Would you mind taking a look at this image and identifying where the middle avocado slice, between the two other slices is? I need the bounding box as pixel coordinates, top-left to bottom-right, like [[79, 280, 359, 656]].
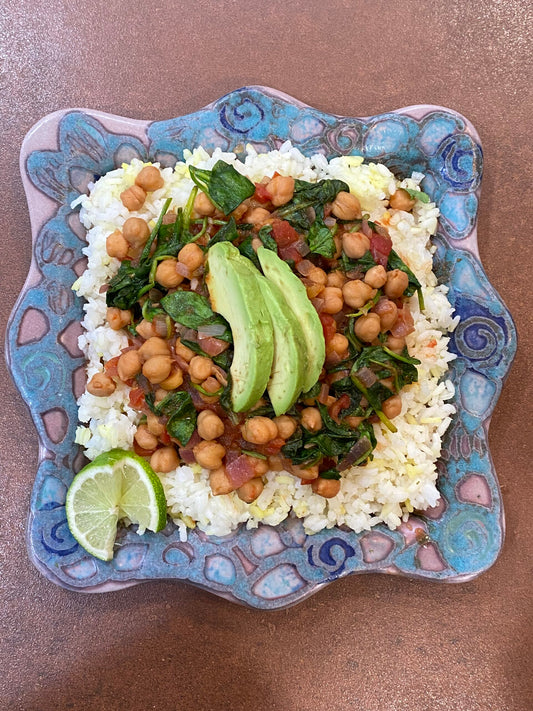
[[258, 275, 307, 415]]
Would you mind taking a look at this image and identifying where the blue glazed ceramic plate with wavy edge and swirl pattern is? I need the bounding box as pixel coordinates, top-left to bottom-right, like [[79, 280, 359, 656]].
[[7, 87, 516, 609]]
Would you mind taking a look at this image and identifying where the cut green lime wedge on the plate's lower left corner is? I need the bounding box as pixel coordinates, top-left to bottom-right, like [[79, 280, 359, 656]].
[[65, 449, 167, 560]]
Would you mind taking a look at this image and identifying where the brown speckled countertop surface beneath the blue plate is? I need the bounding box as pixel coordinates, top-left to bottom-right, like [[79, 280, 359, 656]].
[[0, 0, 533, 711]]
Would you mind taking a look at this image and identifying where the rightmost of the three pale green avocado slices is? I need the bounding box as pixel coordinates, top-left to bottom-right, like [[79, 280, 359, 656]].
[[257, 247, 326, 392]]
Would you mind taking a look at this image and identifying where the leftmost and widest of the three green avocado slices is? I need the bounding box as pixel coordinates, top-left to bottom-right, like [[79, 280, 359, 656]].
[[205, 242, 274, 412]]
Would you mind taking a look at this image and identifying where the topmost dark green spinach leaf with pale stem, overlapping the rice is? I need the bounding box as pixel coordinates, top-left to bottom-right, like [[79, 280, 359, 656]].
[[189, 160, 255, 215]]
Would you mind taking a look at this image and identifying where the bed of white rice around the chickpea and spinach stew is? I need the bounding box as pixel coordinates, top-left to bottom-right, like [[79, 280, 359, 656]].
[[73, 142, 458, 540]]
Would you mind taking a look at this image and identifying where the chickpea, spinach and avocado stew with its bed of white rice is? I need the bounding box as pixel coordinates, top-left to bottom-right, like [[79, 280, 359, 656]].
[[68, 142, 457, 552]]
